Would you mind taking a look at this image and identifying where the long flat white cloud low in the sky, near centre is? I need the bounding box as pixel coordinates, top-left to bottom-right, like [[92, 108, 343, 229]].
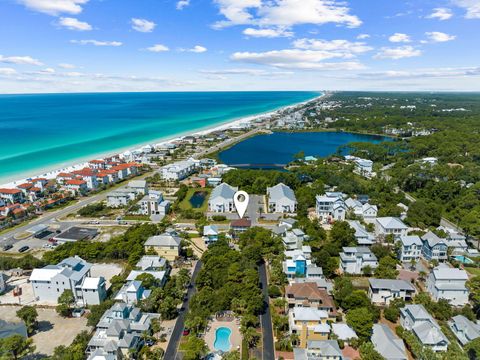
[[231, 49, 363, 70]]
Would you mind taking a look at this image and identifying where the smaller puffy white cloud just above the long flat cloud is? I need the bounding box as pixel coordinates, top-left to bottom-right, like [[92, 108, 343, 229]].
[[293, 39, 373, 58]]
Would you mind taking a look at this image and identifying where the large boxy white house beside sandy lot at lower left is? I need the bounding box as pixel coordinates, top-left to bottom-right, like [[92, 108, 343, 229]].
[[29, 256, 107, 306]]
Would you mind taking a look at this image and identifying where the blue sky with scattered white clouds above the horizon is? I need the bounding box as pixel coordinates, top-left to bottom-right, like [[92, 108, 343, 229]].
[[0, 0, 480, 93]]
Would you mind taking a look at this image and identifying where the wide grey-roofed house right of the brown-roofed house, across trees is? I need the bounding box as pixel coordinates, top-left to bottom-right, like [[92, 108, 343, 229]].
[[368, 279, 415, 305]]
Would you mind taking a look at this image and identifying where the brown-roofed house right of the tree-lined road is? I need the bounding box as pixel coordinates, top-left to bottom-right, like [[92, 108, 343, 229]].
[[285, 282, 337, 321]]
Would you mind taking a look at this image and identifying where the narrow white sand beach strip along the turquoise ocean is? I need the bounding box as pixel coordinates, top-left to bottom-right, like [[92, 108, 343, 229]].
[[0, 91, 328, 188]]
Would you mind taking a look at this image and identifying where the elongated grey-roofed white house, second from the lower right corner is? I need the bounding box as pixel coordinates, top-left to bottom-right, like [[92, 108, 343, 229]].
[[400, 304, 449, 351]]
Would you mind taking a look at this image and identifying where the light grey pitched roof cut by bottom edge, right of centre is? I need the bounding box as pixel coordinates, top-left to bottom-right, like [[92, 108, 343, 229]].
[[371, 324, 408, 360]]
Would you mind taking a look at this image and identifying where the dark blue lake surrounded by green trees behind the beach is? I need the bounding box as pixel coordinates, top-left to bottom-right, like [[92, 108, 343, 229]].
[[218, 132, 389, 169]]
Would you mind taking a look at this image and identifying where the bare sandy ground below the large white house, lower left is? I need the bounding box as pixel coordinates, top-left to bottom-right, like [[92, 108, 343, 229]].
[[0, 306, 90, 356]]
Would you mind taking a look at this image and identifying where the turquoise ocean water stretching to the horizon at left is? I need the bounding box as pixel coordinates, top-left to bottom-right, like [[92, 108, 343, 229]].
[[0, 92, 320, 184]]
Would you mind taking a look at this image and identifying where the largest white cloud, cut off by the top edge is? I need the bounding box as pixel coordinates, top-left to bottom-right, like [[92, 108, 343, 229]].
[[214, 0, 362, 28]]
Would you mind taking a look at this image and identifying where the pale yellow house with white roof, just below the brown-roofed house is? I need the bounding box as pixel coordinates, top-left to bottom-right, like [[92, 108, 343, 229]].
[[288, 307, 330, 348]]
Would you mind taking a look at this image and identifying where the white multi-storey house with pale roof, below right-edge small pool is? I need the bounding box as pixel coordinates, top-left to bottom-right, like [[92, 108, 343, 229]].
[[426, 266, 469, 306]]
